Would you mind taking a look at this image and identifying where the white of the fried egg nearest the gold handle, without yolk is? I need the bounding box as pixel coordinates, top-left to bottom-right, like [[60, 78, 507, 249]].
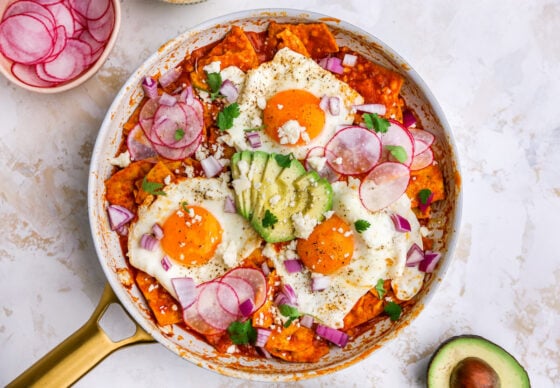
[[128, 178, 261, 296]]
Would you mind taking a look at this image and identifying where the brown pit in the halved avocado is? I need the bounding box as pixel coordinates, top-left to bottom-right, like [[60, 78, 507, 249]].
[[449, 357, 501, 388]]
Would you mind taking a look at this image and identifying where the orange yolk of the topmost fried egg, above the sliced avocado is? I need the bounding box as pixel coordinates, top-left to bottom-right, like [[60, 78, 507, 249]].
[[263, 89, 325, 146]]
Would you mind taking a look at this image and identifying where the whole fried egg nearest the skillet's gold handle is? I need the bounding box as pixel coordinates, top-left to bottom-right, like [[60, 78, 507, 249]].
[[128, 178, 261, 297]]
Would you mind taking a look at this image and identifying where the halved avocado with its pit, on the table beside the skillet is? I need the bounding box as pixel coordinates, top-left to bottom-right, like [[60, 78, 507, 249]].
[[427, 335, 531, 388]]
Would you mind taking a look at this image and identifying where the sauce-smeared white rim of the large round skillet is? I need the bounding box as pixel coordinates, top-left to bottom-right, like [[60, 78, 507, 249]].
[[88, 8, 462, 382]]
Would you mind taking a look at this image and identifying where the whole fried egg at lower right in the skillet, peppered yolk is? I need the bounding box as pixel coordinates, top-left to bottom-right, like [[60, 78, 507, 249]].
[[263, 179, 423, 328]]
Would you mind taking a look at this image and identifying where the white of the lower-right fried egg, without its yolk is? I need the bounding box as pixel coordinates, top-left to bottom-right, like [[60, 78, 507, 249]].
[[263, 179, 424, 328]]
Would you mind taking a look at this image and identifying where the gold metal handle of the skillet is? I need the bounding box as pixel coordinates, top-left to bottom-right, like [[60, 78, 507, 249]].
[[7, 284, 154, 388]]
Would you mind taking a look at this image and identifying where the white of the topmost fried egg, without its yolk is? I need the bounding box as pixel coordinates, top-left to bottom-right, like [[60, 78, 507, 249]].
[[223, 48, 364, 159]]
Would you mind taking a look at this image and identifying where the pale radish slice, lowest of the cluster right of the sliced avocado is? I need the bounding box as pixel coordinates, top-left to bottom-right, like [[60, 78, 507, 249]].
[[360, 162, 410, 212]]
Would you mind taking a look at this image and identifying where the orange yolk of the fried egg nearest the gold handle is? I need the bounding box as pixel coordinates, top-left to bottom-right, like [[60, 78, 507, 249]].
[[161, 206, 223, 266]]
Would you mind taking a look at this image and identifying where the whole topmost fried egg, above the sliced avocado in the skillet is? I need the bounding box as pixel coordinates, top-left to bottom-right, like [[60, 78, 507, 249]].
[[224, 48, 363, 159]]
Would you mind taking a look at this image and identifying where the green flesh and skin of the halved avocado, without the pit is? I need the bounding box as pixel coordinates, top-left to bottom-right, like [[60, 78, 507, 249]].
[[426, 334, 531, 388]]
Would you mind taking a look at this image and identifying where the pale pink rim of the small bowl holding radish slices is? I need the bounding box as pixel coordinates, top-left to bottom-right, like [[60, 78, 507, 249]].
[[0, 0, 122, 94]]
